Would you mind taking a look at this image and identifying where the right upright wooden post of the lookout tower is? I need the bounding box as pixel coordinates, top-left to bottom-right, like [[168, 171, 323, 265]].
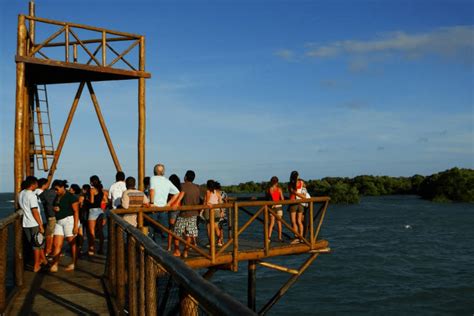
[[138, 36, 146, 191]]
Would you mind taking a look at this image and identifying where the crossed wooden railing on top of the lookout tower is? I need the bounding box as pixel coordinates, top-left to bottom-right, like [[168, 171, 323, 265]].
[[19, 15, 145, 71]]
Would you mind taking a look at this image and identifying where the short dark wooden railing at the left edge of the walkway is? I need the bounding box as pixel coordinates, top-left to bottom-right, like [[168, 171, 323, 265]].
[[0, 212, 24, 315]]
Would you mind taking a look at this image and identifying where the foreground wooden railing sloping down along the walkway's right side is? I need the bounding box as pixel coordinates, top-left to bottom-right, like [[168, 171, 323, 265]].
[[106, 213, 255, 316]]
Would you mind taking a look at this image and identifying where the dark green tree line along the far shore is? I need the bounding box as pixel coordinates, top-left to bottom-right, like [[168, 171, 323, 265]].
[[223, 168, 474, 204]]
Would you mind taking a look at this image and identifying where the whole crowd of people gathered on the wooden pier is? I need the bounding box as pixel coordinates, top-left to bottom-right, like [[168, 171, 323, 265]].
[[18, 164, 308, 272]]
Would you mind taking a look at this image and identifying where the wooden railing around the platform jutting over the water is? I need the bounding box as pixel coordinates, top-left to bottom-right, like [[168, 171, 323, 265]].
[[114, 197, 330, 271]]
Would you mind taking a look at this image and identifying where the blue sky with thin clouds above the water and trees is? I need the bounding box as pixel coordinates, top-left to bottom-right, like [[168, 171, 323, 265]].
[[0, 0, 474, 191]]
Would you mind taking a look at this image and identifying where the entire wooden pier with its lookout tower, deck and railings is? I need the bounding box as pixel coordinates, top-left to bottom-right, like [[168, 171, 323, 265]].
[[0, 2, 330, 316]]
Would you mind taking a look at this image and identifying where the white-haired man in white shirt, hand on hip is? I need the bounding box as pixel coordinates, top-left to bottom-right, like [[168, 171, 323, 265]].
[[150, 164, 179, 237]]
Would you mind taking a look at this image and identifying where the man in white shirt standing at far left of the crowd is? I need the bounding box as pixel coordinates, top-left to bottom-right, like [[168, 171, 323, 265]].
[[19, 176, 48, 272]]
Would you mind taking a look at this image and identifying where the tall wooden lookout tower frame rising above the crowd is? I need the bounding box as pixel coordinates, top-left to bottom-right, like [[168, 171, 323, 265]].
[[14, 1, 151, 200]]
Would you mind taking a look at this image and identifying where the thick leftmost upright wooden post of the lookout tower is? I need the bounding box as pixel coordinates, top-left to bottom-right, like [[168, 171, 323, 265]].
[[14, 15, 27, 198]]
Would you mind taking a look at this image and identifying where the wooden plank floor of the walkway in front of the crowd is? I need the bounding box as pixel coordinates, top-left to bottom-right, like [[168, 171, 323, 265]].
[[9, 255, 110, 315]]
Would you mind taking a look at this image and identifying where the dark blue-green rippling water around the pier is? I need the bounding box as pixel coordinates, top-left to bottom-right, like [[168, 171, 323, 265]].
[[0, 193, 474, 315]]
